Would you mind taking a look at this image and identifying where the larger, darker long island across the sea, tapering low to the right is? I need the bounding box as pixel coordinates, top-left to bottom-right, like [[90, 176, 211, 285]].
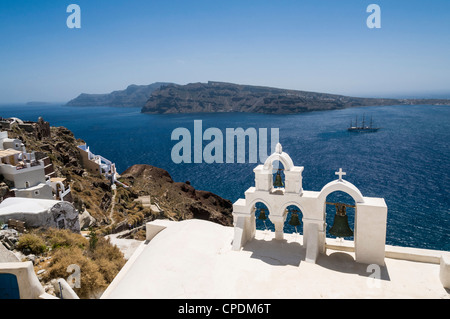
[[142, 82, 450, 114]]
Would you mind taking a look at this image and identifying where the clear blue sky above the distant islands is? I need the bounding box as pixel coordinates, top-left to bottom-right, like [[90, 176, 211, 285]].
[[0, 0, 450, 103]]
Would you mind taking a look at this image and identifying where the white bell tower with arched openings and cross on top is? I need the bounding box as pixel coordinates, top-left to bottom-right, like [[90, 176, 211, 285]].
[[233, 143, 387, 265]]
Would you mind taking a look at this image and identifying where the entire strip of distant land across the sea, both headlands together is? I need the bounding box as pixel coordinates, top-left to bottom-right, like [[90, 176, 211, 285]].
[[67, 82, 450, 114]]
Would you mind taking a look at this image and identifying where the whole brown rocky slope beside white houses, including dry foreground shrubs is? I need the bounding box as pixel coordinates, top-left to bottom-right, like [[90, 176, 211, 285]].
[[0, 118, 232, 299]]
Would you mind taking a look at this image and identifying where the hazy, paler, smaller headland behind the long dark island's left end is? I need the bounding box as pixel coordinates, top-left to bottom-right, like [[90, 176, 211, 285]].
[[67, 82, 172, 107]]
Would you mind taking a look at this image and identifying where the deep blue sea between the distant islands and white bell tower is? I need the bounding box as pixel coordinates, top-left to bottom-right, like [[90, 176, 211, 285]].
[[0, 104, 450, 251]]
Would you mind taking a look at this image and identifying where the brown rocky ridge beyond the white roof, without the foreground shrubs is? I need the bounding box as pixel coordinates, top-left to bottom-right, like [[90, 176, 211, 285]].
[[2, 117, 232, 234]]
